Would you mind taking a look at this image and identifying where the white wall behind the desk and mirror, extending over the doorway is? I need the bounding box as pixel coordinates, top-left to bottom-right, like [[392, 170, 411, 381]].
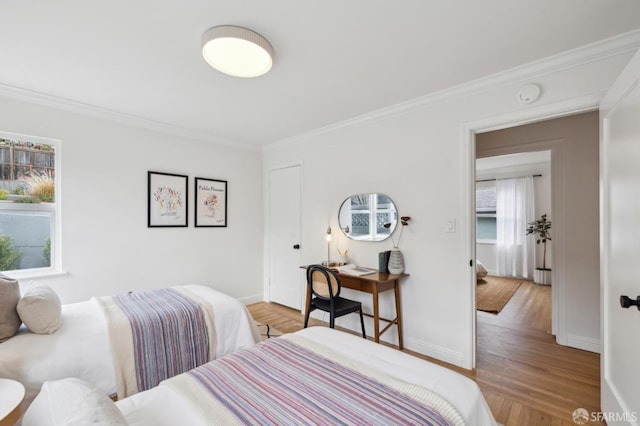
[[264, 46, 631, 367]]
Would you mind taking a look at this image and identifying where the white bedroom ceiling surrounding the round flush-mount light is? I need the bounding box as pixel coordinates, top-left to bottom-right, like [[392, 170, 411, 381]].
[[0, 0, 640, 145]]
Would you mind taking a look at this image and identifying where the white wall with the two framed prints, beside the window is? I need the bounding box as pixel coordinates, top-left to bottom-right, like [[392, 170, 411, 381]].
[[0, 98, 263, 302]]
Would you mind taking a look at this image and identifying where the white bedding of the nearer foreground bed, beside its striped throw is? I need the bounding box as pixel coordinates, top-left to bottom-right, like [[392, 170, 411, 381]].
[[116, 327, 496, 426]]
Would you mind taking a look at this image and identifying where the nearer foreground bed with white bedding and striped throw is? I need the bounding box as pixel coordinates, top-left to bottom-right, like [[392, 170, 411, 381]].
[[109, 327, 496, 426]]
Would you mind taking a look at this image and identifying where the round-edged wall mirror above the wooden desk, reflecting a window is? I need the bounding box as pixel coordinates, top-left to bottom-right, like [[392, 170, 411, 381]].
[[338, 194, 398, 241]]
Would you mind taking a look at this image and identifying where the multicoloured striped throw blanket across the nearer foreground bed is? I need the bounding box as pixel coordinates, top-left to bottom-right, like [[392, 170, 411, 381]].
[[185, 338, 459, 425]]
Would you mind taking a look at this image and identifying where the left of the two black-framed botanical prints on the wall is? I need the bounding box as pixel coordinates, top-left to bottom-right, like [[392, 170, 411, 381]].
[[147, 171, 189, 228]]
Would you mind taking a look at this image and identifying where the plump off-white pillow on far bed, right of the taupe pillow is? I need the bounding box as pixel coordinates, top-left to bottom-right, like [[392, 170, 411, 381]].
[[16, 284, 62, 334]]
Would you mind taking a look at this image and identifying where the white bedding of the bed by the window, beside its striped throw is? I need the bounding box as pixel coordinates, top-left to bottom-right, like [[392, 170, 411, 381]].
[[0, 285, 260, 408]]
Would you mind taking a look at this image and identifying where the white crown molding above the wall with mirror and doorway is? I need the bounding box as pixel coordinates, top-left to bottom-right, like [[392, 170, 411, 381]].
[[263, 30, 640, 150]]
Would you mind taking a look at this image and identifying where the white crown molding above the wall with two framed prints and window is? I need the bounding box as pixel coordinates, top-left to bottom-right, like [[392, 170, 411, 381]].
[[0, 83, 260, 152]]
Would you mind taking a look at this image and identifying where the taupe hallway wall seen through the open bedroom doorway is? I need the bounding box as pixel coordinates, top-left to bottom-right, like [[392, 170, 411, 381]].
[[470, 111, 600, 368]]
